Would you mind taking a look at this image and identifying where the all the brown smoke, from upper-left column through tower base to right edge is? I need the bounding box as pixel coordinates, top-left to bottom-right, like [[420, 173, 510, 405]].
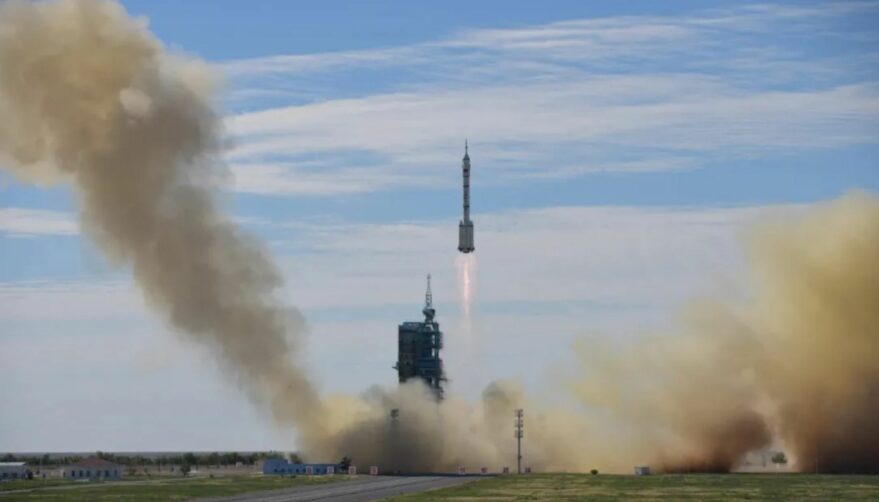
[[0, 0, 879, 472]]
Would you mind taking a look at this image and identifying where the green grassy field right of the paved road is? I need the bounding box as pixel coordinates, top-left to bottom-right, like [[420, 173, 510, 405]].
[[393, 474, 879, 502]]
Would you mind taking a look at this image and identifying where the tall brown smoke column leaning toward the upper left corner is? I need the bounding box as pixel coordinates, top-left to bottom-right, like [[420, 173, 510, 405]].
[[0, 0, 319, 436]]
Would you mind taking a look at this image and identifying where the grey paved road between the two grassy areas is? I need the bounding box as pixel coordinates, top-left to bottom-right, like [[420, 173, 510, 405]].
[[199, 476, 479, 502]]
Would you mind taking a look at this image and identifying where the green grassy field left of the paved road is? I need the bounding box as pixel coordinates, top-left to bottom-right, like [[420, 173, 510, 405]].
[[0, 476, 347, 502]]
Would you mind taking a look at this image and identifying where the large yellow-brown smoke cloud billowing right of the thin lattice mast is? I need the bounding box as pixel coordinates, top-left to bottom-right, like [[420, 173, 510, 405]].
[[575, 192, 879, 473]]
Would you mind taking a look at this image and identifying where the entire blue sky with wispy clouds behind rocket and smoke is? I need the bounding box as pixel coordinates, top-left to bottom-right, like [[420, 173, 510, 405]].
[[0, 0, 879, 450]]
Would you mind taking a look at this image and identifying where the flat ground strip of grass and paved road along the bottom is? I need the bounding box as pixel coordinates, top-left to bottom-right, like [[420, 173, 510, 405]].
[[0, 474, 879, 502]]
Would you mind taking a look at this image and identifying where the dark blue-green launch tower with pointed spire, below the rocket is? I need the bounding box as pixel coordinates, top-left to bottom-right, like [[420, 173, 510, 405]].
[[394, 275, 446, 401]]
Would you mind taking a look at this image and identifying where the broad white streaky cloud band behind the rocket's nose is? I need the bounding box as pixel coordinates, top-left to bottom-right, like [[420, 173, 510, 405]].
[[229, 81, 879, 194]]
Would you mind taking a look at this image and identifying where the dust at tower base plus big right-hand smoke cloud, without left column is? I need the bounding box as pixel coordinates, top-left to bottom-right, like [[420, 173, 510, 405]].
[[300, 193, 879, 472]]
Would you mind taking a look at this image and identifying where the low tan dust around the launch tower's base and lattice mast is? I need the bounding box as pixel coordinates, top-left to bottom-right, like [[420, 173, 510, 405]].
[[306, 381, 590, 473]]
